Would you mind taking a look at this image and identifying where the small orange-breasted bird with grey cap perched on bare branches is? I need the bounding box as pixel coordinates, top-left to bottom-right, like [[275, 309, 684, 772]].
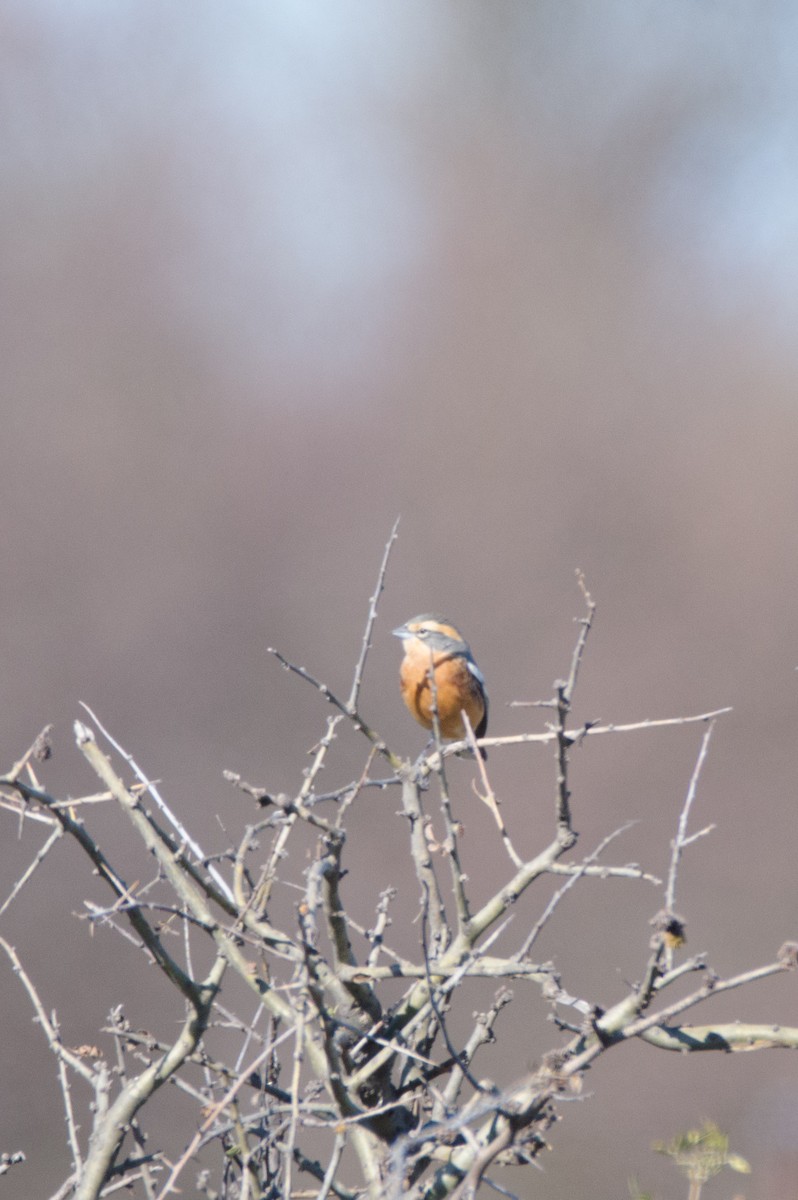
[[392, 612, 488, 758]]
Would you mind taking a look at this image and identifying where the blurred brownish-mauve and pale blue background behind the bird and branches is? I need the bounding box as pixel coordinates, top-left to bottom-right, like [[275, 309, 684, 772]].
[[0, 0, 798, 1200]]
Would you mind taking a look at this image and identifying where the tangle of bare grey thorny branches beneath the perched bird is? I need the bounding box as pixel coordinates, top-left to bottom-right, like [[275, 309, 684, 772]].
[[0, 552, 798, 1200]]
